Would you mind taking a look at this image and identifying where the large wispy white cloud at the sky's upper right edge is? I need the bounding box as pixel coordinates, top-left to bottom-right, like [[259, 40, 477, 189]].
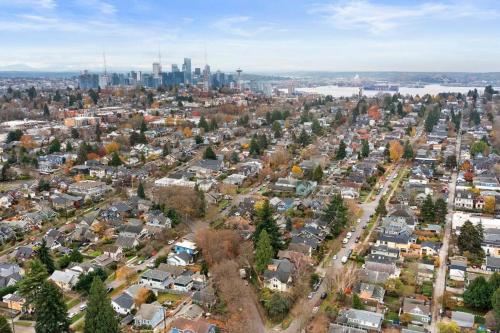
[[310, 0, 498, 33]]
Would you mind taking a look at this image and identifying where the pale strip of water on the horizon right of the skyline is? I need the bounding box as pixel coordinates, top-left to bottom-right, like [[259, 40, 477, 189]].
[[295, 84, 484, 97]]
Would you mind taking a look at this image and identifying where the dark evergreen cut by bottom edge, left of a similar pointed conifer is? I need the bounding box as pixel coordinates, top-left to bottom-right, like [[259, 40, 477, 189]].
[[34, 281, 70, 333]]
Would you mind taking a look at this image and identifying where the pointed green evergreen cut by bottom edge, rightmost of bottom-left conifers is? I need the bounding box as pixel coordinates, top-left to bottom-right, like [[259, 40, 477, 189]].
[[84, 277, 120, 333]]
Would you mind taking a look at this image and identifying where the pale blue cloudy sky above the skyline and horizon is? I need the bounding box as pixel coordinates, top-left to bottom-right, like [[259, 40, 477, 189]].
[[0, 0, 500, 72]]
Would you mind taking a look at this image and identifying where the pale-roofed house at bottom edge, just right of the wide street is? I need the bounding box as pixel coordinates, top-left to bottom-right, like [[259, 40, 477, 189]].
[[336, 309, 384, 332]]
